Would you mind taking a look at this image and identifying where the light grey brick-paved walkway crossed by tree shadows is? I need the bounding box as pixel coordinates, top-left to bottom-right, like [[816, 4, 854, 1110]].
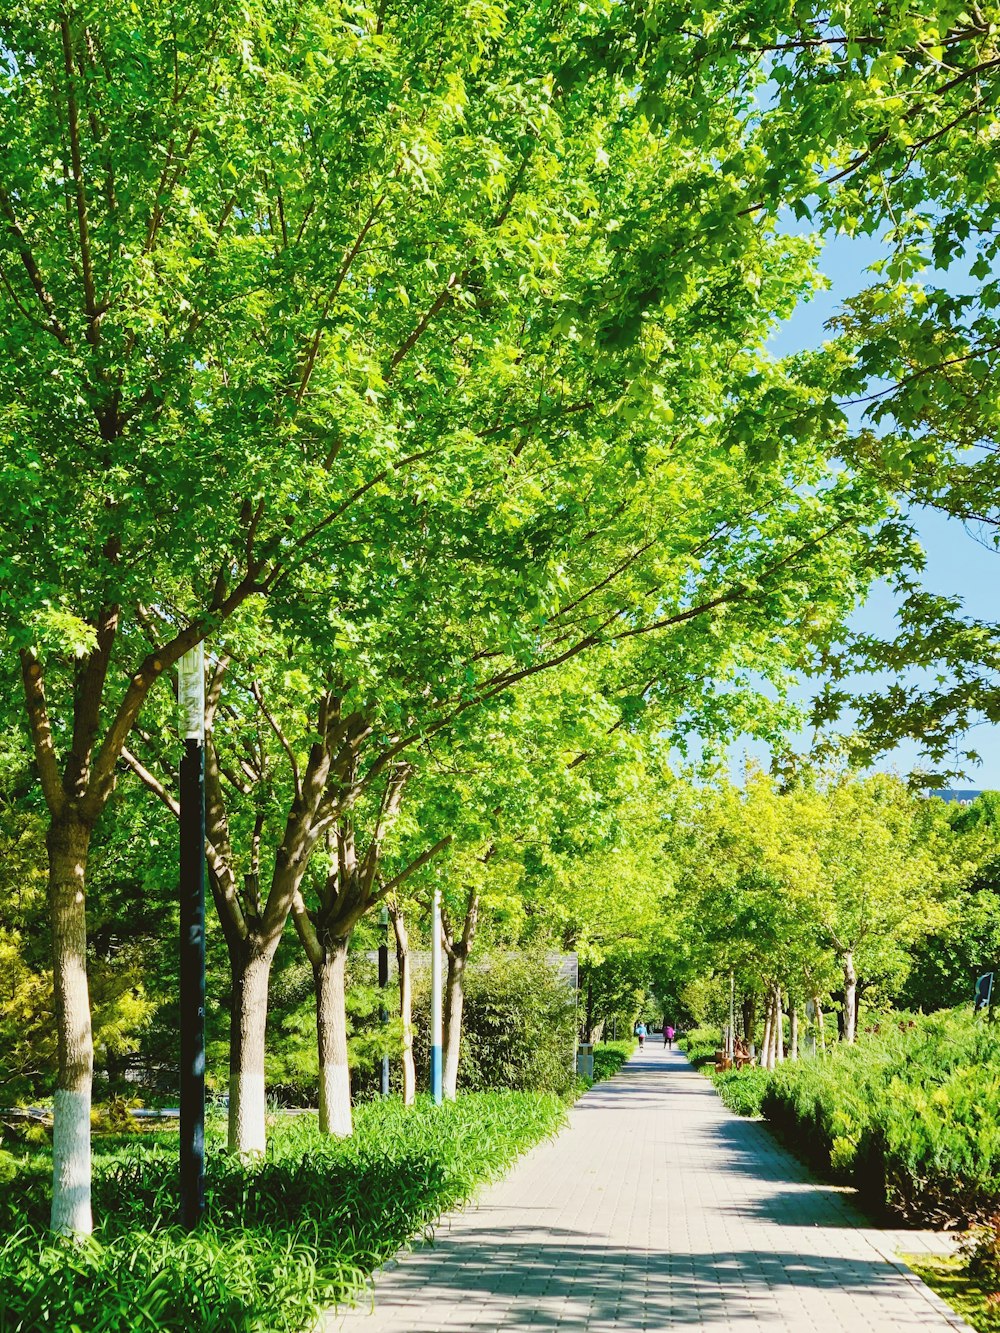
[[324, 1045, 967, 1333]]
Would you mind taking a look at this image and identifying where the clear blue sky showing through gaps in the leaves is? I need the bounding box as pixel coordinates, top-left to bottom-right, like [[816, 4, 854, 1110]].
[[735, 236, 1000, 789]]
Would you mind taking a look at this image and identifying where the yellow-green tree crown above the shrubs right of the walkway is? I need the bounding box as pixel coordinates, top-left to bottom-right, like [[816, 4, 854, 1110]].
[[677, 774, 955, 1018]]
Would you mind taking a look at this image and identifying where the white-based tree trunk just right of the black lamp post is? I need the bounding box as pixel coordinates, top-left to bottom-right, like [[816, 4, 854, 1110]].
[[229, 952, 272, 1156]]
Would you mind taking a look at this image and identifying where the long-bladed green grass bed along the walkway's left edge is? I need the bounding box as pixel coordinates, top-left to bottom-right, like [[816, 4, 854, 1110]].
[[0, 1092, 565, 1333]]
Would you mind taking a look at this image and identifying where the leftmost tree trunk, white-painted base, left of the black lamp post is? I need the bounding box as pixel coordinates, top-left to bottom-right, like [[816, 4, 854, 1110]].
[[45, 814, 93, 1234]]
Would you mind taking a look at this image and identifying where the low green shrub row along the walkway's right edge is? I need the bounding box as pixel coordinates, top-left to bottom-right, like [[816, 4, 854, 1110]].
[[713, 1010, 1000, 1226]]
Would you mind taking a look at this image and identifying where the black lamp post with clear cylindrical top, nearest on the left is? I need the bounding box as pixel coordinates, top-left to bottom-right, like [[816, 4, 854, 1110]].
[[177, 644, 205, 1230]]
